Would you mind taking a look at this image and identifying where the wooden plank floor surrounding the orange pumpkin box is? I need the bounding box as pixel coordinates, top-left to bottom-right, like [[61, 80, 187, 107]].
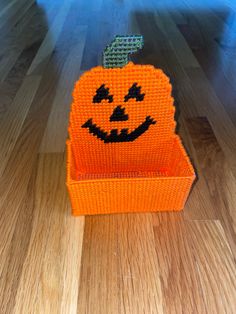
[[0, 0, 236, 314]]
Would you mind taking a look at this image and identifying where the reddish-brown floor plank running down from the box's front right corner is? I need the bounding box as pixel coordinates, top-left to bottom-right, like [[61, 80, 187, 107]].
[[153, 213, 206, 314]]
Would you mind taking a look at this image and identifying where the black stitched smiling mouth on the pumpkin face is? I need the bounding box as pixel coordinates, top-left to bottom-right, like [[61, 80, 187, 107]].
[[81, 116, 156, 143]]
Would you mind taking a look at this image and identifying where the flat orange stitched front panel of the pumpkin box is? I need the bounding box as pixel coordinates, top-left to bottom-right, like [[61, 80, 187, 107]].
[[68, 178, 193, 215]]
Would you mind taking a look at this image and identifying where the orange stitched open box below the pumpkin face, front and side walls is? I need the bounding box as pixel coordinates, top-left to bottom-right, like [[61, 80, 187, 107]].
[[67, 135, 195, 215]]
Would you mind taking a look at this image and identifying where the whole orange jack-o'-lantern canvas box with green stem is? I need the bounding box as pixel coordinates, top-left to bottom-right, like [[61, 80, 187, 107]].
[[67, 36, 195, 215]]
